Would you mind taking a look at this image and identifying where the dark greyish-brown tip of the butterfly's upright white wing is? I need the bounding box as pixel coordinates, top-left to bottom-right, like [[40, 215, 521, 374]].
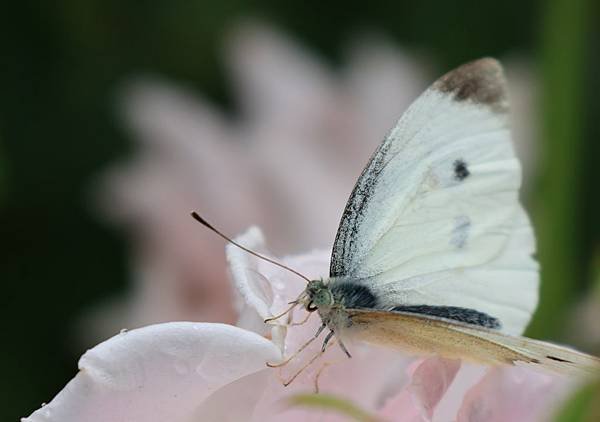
[[433, 57, 508, 111]]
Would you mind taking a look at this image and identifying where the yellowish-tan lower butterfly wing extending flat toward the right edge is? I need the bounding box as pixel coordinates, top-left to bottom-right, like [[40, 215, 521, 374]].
[[344, 309, 600, 375]]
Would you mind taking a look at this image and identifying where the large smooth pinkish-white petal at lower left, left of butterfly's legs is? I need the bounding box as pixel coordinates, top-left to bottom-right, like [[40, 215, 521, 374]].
[[23, 322, 280, 422]]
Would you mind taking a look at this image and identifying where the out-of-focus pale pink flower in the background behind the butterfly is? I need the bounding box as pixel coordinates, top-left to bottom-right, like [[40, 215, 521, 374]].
[[82, 25, 430, 343]]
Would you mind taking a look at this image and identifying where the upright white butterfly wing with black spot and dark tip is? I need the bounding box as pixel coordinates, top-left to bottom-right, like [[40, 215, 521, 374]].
[[330, 59, 538, 334]]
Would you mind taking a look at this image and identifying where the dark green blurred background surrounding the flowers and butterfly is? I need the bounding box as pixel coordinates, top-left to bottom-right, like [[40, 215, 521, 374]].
[[0, 0, 600, 420]]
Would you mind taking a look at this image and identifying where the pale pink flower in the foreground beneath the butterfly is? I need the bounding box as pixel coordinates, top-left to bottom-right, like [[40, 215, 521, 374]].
[[24, 228, 569, 422]]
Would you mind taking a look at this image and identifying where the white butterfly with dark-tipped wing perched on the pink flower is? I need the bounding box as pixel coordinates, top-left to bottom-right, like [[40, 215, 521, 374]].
[[193, 58, 600, 373]]
